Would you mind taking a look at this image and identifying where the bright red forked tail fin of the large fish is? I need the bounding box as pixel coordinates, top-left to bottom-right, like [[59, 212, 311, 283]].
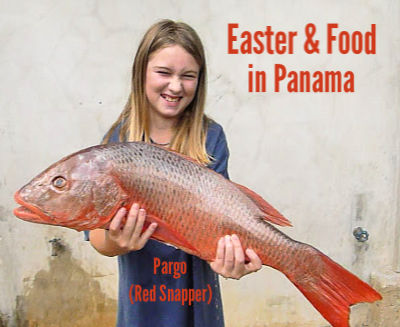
[[288, 244, 382, 327]]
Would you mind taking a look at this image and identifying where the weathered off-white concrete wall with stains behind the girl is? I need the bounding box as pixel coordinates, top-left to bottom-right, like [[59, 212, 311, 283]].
[[0, 0, 400, 327]]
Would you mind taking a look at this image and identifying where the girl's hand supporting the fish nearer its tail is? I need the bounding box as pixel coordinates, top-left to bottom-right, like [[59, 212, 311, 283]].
[[210, 235, 262, 279]]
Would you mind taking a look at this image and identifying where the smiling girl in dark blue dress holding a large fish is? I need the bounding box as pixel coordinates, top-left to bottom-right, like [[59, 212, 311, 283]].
[[86, 20, 261, 327]]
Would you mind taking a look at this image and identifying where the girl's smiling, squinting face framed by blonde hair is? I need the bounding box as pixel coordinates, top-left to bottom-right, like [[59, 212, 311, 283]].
[[145, 45, 200, 123]]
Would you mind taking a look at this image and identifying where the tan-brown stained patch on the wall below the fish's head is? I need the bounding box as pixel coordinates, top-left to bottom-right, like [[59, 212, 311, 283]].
[[13, 241, 117, 327]]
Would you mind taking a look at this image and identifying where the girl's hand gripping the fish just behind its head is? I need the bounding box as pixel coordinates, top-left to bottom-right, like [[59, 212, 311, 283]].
[[105, 203, 157, 254]]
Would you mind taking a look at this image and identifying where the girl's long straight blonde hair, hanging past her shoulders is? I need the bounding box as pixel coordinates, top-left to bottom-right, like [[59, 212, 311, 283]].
[[103, 19, 210, 164]]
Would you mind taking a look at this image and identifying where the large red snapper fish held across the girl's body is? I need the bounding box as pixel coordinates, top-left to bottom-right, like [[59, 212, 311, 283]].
[[14, 142, 381, 327]]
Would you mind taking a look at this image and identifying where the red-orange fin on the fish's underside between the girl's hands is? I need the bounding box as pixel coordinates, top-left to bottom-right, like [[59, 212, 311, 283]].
[[145, 213, 199, 256]]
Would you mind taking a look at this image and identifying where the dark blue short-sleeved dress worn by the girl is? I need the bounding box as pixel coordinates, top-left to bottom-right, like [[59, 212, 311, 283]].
[[86, 122, 229, 327]]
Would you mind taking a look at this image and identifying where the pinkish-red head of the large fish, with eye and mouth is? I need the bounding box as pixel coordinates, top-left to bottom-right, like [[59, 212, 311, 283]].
[[14, 151, 127, 231]]
